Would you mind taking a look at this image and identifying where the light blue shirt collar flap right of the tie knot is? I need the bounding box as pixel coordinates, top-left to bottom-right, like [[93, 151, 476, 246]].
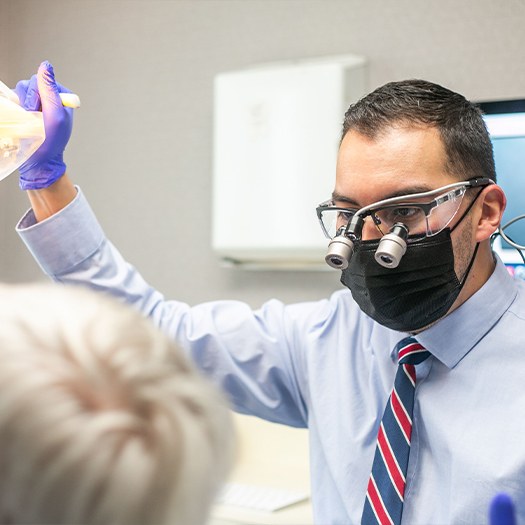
[[410, 255, 517, 368]]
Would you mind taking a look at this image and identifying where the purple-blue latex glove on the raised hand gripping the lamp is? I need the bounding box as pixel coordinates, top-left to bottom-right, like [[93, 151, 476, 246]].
[[15, 61, 73, 190]]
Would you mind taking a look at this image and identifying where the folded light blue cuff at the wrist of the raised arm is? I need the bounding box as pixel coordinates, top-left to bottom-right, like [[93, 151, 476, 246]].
[[16, 187, 105, 276]]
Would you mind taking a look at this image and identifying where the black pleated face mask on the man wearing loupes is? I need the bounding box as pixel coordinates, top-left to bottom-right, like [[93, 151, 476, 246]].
[[341, 229, 479, 332]]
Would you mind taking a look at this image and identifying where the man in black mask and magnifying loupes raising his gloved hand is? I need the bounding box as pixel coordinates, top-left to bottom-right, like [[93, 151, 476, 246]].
[[13, 64, 525, 525]]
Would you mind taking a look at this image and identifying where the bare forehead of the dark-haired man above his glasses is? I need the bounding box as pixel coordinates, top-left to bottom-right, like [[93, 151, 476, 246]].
[[334, 125, 458, 207]]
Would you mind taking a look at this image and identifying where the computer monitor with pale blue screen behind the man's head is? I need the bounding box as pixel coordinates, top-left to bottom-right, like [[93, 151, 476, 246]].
[[478, 99, 525, 279]]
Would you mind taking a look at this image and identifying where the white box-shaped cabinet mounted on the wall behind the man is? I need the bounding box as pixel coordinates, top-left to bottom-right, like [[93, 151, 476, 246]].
[[212, 55, 368, 269]]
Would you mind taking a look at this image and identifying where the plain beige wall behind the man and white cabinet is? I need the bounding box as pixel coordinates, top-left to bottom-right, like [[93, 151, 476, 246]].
[[0, 0, 525, 306]]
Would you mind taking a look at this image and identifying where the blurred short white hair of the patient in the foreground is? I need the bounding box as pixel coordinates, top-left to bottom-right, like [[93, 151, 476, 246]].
[[0, 284, 234, 525]]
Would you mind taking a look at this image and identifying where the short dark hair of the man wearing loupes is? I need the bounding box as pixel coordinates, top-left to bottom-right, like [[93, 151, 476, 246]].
[[342, 80, 496, 181]]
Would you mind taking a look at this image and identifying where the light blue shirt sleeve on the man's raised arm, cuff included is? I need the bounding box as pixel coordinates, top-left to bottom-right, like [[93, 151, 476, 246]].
[[17, 189, 312, 427]]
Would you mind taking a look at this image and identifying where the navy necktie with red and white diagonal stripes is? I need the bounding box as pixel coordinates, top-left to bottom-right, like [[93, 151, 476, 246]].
[[361, 337, 430, 525]]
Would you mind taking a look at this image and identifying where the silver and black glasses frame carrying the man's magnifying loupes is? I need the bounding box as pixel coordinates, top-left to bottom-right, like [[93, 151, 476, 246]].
[[316, 177, 495, 239]]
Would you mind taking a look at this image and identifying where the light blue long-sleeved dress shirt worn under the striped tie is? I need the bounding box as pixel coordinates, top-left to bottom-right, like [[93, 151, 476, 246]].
[[18, 191, 525, 525]]
